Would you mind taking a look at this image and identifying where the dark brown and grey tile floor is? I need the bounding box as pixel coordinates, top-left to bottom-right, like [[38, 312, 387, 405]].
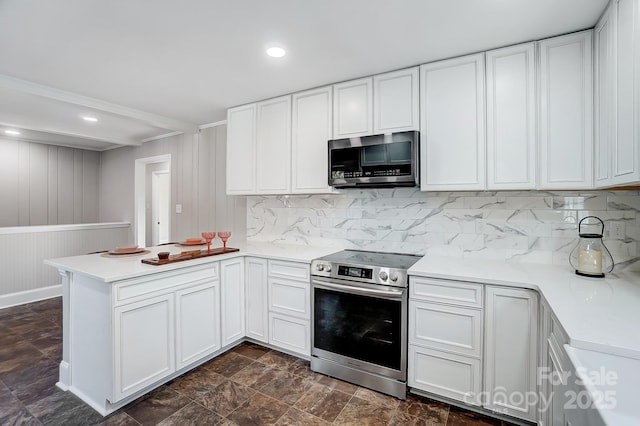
[[0, 298, 507, 426]]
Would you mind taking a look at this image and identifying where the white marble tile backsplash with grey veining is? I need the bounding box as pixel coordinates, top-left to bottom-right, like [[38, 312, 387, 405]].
[[247, 188, 640, 269]]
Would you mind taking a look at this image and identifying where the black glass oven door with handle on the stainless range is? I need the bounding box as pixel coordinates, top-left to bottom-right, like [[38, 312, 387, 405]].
[[311, 277, 408, 381]]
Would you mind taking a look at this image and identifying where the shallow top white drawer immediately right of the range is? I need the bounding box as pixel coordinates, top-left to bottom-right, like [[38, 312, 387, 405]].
[[409, 277, 482, 308]]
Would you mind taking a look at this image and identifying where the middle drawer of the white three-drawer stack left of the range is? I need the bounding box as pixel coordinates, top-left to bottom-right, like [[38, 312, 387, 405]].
[[269, 278, 311, 319]]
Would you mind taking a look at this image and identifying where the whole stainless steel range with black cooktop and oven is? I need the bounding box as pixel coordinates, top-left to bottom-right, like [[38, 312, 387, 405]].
[[311, 250, 420, 399]]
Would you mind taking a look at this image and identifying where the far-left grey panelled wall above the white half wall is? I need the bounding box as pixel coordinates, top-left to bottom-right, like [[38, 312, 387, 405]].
[[0, 138, 100, 227]]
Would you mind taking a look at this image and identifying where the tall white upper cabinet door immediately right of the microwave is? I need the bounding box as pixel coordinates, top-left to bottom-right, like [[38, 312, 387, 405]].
[[420, 53, 485, 191]]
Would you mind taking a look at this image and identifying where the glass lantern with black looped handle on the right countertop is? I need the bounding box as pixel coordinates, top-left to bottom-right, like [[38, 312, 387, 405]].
[[569, 216, 614, 278]]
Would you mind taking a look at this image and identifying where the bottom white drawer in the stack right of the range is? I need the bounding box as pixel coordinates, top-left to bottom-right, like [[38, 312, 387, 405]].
[[408, 345, 481, 405]]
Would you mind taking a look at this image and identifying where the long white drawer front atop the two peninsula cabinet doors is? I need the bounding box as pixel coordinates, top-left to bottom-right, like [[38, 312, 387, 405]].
[[114, 262, 219, 306]]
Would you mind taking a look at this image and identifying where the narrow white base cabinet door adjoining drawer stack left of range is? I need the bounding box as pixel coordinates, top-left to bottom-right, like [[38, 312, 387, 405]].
[[245, 257, 269, 343]]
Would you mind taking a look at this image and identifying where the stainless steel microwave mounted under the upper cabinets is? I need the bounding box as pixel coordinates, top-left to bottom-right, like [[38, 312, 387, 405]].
[[329, 131, 420, 188]]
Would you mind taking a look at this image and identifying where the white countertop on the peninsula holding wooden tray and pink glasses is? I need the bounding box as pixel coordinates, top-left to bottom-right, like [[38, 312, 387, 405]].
[[44, 243, 339, 282]]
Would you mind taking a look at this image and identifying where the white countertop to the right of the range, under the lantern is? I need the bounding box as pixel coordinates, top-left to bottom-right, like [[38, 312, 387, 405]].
[[409, 256, 640, 359]]
